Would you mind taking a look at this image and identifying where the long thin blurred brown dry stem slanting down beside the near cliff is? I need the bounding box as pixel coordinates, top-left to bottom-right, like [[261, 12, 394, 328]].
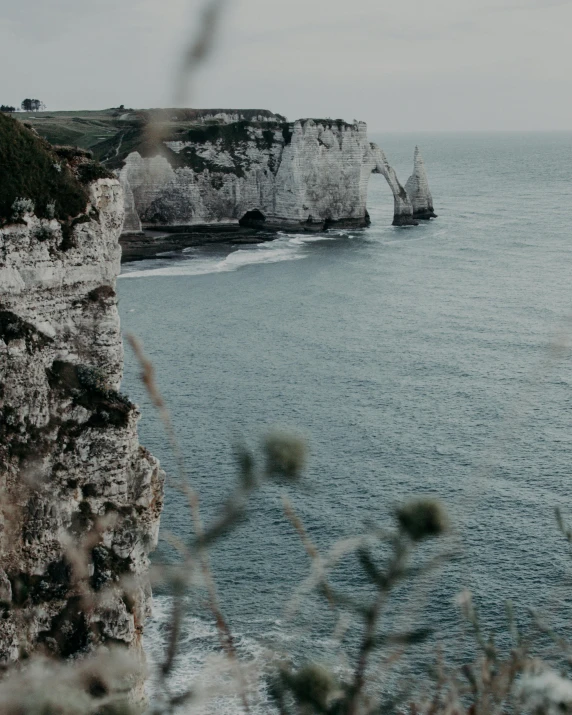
[[127, 334, 250, 713]]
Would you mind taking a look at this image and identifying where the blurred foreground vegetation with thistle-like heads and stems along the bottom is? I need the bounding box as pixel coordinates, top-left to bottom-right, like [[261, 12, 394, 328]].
[[0, 340, 572, 715]]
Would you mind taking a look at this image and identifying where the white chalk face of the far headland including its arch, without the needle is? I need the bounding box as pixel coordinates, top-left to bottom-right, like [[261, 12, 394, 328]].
[[119, 119, 415, 230]]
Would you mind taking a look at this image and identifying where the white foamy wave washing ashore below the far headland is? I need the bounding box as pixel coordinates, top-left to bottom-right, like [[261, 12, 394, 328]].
[[119, 234, 338, 278]]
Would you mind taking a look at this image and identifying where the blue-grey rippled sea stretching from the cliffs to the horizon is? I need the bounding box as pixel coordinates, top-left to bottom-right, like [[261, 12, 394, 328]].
[[118, 133, 572, 712]]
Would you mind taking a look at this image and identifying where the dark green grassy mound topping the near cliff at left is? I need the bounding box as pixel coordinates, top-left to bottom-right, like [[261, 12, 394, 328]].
[[0, 114, 88, 221]]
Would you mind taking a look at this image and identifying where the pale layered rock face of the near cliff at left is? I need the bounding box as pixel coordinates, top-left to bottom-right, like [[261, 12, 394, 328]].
[[0, 179, 164, 688]]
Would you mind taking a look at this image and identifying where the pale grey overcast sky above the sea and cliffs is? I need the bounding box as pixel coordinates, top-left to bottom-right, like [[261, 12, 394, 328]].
[[0, 0, 572, 132]]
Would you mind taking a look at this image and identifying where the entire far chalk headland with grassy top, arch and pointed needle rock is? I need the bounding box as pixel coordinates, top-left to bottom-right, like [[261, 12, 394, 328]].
[[12, 107, 434, 235]]
